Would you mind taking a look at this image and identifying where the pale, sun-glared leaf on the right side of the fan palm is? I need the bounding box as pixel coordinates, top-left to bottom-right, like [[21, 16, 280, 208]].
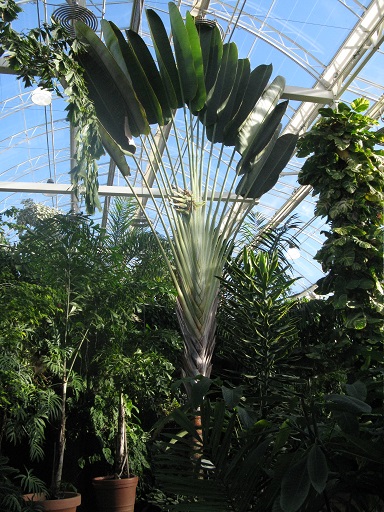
[[235, 76, 285, 156]]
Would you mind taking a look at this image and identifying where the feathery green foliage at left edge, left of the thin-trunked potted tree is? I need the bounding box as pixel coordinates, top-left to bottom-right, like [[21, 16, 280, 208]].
[[0, 218, 60, 461]]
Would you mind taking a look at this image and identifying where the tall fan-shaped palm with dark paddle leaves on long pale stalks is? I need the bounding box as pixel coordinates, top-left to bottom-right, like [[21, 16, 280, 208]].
[[76, 3, 297, 376]]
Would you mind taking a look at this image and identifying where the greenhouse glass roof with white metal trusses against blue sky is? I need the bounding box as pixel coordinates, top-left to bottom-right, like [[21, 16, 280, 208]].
[[0, 0, 384, 293]]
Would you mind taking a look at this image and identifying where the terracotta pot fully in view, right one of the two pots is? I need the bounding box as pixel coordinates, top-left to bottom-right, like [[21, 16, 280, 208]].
[[92, 476, 139, 512]]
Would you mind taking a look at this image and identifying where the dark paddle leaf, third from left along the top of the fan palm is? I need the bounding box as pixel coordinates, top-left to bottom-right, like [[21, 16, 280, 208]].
[[127, 30, 172, 124]]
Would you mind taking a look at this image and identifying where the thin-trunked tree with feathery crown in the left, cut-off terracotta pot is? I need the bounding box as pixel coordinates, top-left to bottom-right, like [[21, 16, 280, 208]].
[[2, 210, 112, 512]]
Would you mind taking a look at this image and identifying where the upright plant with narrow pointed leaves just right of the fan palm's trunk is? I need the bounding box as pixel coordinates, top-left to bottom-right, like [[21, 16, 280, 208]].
[[220, 247, 298, 417]]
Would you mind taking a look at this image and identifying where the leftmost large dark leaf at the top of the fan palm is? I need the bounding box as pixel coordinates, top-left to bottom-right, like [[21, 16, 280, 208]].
[[75, 21, 149, 137]]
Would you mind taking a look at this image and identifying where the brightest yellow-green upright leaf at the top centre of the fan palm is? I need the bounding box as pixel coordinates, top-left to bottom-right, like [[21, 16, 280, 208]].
[[185, 12, 207, 114]]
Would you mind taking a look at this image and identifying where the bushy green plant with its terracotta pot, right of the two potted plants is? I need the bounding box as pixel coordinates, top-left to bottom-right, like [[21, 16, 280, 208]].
[[90, 328, 175, 512]]
